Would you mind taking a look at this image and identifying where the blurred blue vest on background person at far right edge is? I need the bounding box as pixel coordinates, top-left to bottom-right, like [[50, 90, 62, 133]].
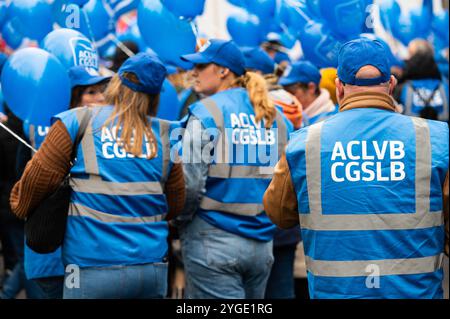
[[400, 79, 449, 121]]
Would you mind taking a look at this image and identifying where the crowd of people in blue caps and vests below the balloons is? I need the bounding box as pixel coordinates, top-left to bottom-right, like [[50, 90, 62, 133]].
[[0, 28, 449, 299]]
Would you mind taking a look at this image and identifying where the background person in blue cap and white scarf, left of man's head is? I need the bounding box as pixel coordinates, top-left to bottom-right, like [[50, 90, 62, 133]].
[[278, 61, 338, 125]]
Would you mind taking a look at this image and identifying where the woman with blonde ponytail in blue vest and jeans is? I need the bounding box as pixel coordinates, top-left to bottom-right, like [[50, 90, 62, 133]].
[[176, 39, 292, 299]]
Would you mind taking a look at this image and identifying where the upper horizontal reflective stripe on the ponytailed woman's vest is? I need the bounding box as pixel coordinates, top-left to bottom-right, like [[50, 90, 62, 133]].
[[208, 164, 273, 179]]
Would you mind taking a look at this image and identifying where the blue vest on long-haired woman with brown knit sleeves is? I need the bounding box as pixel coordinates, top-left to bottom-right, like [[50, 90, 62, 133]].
[[56, 106, 172, 267]]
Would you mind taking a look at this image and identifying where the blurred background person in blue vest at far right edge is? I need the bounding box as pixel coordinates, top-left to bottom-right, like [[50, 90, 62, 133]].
[[395, 39, 449, 122]]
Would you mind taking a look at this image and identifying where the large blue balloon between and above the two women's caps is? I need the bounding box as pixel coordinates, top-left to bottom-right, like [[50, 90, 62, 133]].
[[137, 0, 196, 69]]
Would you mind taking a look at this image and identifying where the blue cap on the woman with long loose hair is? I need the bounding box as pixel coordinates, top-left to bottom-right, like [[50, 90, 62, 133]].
[[118, 52, 167, 94]]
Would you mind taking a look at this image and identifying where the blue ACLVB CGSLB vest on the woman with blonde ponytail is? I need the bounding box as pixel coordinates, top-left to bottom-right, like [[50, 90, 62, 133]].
[[189, 88, 292, 241]]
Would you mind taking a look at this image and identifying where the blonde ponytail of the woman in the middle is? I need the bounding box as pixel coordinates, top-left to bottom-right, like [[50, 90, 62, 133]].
[[232, 72, 277, 128]]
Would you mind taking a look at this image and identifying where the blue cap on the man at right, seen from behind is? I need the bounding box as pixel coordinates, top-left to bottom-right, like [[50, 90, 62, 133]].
[[338, 38, 391, 86]]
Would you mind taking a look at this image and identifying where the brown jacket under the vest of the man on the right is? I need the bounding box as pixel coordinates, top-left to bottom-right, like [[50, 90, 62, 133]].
[[264, 93, 449, 255]]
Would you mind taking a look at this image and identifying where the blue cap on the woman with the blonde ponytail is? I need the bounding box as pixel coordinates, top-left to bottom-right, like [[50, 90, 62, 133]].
[[181, 39, 245, 76]]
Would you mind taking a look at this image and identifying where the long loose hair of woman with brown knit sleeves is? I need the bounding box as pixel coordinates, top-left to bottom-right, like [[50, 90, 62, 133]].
[[104, 73, 159, 159]]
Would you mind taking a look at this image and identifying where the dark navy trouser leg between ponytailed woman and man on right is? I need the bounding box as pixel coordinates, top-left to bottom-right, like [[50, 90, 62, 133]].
[[266, 244, 297, 299]]
